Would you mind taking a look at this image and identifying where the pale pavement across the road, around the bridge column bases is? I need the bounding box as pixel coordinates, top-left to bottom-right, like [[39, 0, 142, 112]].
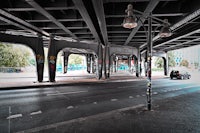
[[0, 71, 147, 89]]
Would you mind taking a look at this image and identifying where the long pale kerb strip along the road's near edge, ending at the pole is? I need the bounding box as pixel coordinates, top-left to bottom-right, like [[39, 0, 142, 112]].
[[16, 104, 145, 133]]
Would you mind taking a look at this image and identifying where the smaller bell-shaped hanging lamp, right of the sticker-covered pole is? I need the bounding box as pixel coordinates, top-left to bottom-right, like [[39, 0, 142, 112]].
[[159, 19, 172, 37]]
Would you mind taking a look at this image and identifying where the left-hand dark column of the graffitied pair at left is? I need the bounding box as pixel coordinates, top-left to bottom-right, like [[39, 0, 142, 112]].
[[35, 36, 45, 82]]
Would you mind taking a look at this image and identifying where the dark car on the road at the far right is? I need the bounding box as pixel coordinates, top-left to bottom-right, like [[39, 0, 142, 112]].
[[170, 70, 191, 80]]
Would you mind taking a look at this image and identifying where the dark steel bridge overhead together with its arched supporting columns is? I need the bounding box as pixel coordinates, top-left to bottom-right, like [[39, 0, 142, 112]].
[[0, 0, 200, 82]]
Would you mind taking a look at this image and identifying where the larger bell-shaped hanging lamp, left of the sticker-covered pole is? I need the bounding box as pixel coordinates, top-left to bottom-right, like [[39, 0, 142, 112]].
[[122, 4, 137, 29]]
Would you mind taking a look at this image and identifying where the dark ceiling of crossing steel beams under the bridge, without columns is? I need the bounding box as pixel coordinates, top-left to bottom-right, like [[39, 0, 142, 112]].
[[0, 0, 200, 51]]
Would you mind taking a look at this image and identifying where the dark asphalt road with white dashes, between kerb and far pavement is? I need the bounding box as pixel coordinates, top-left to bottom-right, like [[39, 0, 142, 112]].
[[0, 78, 200, 133]]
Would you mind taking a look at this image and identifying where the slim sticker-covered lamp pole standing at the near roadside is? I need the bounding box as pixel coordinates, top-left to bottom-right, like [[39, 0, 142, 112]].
[[147, 13, 153, 110]]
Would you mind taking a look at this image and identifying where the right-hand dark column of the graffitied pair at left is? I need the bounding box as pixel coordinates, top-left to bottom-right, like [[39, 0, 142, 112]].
[[48, 37, 58, 82]]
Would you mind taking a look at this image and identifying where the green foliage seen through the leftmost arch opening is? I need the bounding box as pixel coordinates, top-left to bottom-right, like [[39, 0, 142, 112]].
[[0, 43, 30, 67]]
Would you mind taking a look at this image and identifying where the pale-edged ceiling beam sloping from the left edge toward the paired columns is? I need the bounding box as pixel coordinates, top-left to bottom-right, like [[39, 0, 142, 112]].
[[0, 9, 49, 36]]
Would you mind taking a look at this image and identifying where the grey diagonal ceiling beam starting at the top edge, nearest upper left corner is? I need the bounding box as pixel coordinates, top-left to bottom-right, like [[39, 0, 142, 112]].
[[25, 0, 77, 39]]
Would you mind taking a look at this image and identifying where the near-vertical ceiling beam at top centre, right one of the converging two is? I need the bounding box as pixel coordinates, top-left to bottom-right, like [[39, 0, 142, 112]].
[[92, 0, 108, 45]]
